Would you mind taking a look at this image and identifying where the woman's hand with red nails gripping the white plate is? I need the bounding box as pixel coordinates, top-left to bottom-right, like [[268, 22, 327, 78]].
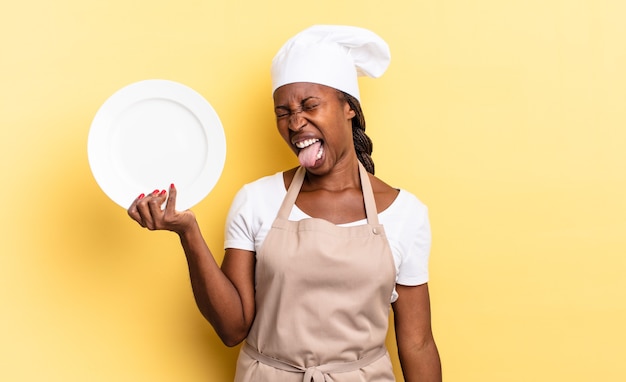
[[128, 184, 197, 235]]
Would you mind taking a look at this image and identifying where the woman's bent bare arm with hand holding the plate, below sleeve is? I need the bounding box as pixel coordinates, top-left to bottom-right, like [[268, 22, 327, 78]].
[[128, 185, 255, 346]]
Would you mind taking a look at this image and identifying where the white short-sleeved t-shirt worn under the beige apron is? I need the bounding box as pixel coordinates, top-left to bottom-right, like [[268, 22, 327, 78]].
[[224, 172, 431, 302]]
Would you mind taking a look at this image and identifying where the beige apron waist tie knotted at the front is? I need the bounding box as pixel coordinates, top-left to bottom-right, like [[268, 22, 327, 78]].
[[243, 342, 387, 382]]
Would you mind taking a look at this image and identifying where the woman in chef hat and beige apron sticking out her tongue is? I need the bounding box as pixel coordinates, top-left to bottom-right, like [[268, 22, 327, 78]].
[[128, 25, 441, 382]]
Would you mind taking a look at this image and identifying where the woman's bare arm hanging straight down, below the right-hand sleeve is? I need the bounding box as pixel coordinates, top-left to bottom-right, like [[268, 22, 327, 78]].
[[393, 284, 441, 382]]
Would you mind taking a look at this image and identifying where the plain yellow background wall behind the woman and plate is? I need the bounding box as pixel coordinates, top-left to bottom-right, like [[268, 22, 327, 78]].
[[0, 0, 626, 382]]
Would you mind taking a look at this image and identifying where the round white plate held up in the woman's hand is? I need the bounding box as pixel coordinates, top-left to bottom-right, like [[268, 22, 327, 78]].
[[87, 80, 226, 210]]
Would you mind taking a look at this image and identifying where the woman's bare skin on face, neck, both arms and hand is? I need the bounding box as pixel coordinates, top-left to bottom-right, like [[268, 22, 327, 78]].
[[128, 83, 441, 382]]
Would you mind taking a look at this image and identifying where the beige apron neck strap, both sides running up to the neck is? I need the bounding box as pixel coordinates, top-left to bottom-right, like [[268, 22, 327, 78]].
[[278, 162, 378, 225]]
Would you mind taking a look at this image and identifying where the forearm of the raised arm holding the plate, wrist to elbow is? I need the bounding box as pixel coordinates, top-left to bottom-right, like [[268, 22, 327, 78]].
[[179, 224, 249, 346]]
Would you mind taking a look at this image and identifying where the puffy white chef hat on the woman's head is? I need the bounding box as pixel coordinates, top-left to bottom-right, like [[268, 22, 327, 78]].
[[272, 25, 390, 100]]
